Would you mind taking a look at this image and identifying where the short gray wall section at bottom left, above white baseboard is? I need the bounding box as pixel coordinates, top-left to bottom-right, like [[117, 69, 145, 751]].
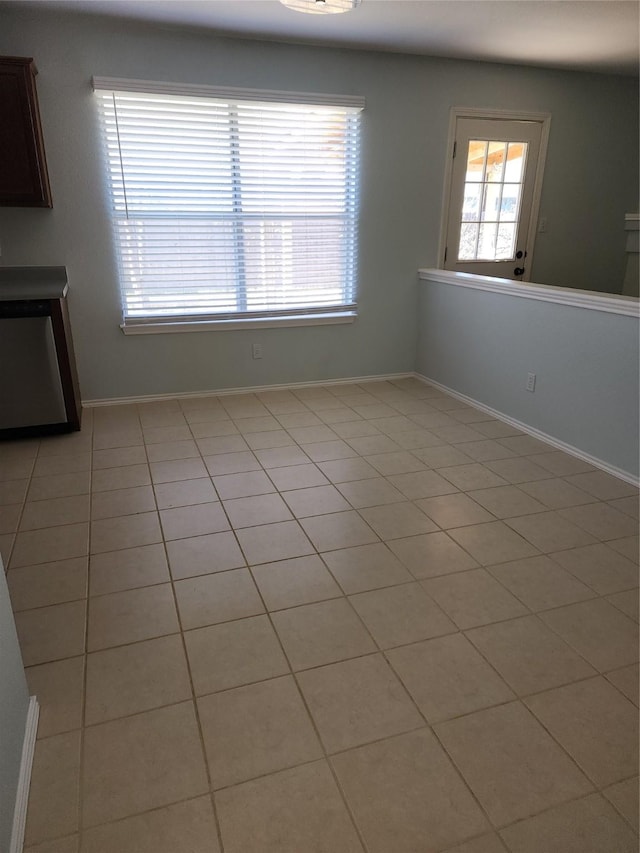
[[0, 557, 29, 850]]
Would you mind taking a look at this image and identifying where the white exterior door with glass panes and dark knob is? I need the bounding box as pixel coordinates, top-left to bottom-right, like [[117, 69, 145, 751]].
[[444, 116, 545, 280]]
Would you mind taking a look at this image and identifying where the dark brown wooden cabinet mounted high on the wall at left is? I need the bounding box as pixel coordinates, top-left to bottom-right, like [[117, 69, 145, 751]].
[[0, 56, 53, 207]]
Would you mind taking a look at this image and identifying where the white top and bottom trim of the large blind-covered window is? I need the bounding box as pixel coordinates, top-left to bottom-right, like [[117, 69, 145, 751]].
[[91, 76, 365, 335]]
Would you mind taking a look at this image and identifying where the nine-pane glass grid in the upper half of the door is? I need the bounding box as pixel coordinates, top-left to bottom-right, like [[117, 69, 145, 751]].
[[458, 139, 528, 261]]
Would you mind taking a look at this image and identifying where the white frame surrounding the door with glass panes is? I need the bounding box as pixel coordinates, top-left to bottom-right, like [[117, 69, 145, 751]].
[[438, 107, 551, 281]]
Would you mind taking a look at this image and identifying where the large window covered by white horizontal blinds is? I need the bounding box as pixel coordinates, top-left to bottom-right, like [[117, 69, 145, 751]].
[[94, 78, 364, 331]]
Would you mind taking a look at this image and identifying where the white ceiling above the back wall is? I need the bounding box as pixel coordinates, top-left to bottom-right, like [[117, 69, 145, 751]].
[[20, 0, 640, 75]]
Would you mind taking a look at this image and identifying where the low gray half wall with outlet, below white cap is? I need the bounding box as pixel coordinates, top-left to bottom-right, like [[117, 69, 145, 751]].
[[417, 281, 639, 476]]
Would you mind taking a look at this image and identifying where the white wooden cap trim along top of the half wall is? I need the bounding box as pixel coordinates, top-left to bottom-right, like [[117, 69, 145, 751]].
[[418, 269, 640, 317]]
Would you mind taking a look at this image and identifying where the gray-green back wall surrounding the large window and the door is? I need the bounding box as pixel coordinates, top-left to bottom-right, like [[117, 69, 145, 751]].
[[0, 3, 638, 399]]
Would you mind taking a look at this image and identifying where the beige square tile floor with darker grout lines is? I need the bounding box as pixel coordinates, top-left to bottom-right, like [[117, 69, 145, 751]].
[[0, 379, 638, 853]]
